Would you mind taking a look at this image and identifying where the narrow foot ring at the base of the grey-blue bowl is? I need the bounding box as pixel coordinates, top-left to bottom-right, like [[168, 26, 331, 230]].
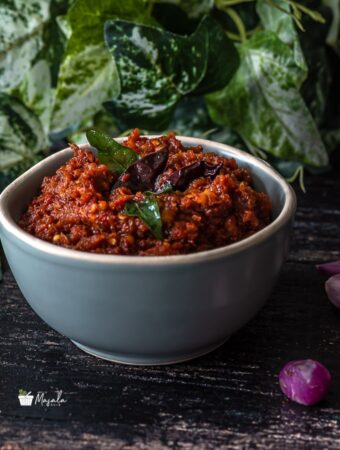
[[72, 336, 230, 366]]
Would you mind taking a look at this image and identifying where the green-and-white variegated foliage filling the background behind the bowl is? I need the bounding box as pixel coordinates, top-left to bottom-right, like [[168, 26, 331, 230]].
[[0, 0, 340, 188]]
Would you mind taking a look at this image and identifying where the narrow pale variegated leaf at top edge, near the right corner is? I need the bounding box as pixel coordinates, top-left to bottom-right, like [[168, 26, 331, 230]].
[[256, 0, 308, 76]]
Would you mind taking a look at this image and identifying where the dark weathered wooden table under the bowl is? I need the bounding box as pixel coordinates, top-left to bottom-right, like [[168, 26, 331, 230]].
[[0, 160, 340, 450]]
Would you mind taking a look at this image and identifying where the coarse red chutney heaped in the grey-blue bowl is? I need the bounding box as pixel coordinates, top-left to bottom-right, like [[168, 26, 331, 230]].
[[19, 130, 271, 255]]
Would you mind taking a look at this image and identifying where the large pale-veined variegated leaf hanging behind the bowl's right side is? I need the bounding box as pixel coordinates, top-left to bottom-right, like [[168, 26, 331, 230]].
[[207, 31, 328, 167]]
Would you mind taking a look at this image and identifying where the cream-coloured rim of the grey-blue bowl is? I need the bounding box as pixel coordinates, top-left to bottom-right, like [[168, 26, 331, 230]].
[[0, 135, 296, 266]]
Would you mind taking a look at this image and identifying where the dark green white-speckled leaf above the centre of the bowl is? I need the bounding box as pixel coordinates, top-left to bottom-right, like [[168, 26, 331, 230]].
[[105, 16, 208, 129]]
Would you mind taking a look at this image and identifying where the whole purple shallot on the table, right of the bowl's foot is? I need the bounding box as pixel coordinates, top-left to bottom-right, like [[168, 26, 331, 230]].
[[279, 359, 332, 406]]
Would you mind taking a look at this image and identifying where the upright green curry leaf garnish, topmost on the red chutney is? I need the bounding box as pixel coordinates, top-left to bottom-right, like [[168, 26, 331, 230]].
[[86, 130, 139, 175]]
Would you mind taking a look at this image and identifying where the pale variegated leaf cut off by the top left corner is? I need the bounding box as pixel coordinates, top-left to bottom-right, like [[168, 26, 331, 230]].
[[0, 0, 50, 92]]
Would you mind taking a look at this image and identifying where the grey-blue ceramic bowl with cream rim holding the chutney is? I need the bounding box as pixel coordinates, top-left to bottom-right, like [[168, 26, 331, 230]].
[[0, 136, 296, 365]]
